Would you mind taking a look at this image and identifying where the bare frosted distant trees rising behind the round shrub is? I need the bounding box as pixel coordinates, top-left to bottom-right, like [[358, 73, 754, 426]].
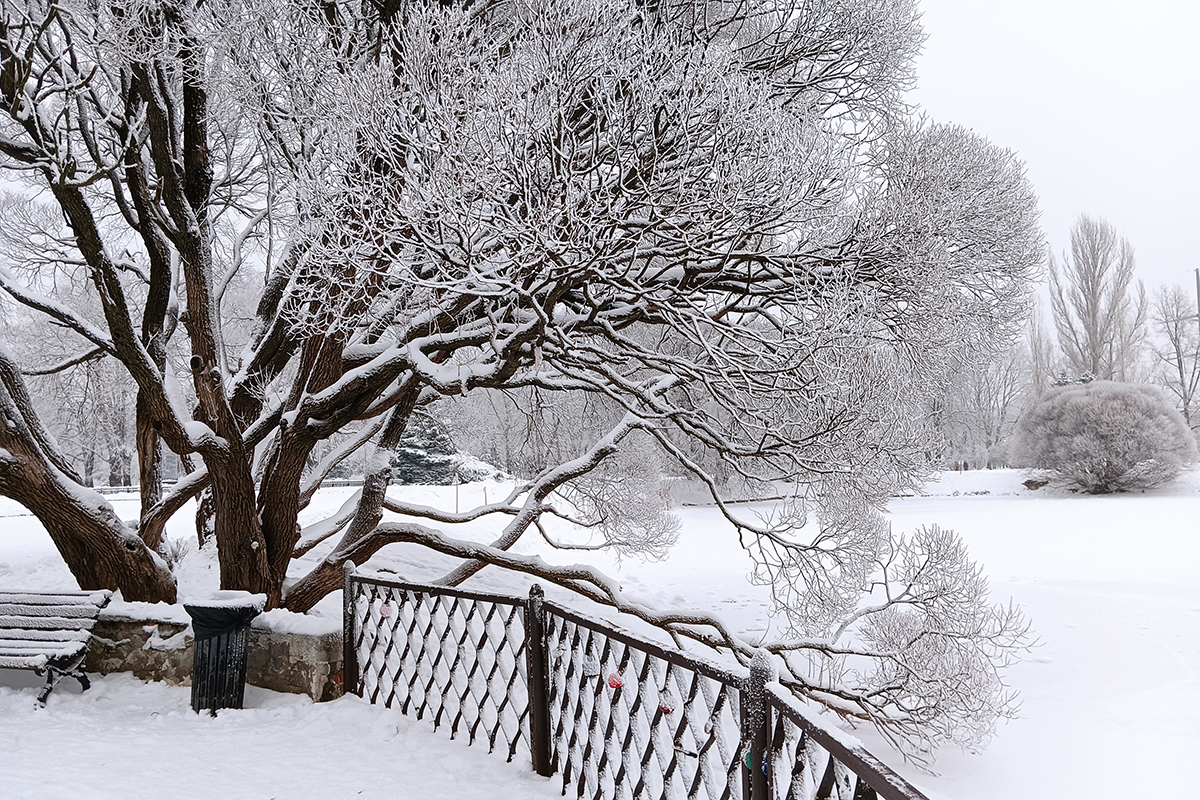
[[928, 215, 1200, 469]]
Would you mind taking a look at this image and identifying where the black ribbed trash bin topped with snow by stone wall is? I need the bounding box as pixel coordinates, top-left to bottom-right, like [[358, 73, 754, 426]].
[[184, 591, 266, 716]]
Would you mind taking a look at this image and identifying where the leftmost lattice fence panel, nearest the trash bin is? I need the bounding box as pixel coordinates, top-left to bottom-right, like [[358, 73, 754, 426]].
[[350, 581, 529, 760]]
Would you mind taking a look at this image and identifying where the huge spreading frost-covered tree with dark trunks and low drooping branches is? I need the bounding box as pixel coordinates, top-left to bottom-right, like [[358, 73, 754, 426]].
[[0, 0, 1042, 742]]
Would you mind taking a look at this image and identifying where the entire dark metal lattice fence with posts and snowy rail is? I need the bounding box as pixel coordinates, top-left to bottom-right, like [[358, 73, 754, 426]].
[[343, 565, 928, 800]]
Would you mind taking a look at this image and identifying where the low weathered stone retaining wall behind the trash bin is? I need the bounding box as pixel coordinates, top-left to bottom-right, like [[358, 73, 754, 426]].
[[86, 614, 342, 702]]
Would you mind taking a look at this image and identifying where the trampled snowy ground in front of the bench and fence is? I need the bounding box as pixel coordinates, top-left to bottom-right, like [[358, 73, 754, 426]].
[[0, 673, 562, 800]]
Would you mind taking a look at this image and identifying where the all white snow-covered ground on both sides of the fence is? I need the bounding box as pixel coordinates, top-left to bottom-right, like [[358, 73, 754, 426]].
[[0, 470, 1200, 800]]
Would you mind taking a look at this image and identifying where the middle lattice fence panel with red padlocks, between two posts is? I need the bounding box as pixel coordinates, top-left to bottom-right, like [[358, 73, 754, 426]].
[[546, 608, 743, 800]]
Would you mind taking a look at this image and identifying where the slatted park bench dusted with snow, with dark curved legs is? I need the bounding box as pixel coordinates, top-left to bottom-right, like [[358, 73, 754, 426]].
[[0, 589, 112, 705]]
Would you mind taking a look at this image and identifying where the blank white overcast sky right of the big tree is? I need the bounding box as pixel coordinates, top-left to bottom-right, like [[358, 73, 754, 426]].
[[910, 0, 1200, 291]]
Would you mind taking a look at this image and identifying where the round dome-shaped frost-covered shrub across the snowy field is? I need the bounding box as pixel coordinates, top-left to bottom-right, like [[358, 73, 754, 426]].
[[1010, 380, 1196, 494]]
